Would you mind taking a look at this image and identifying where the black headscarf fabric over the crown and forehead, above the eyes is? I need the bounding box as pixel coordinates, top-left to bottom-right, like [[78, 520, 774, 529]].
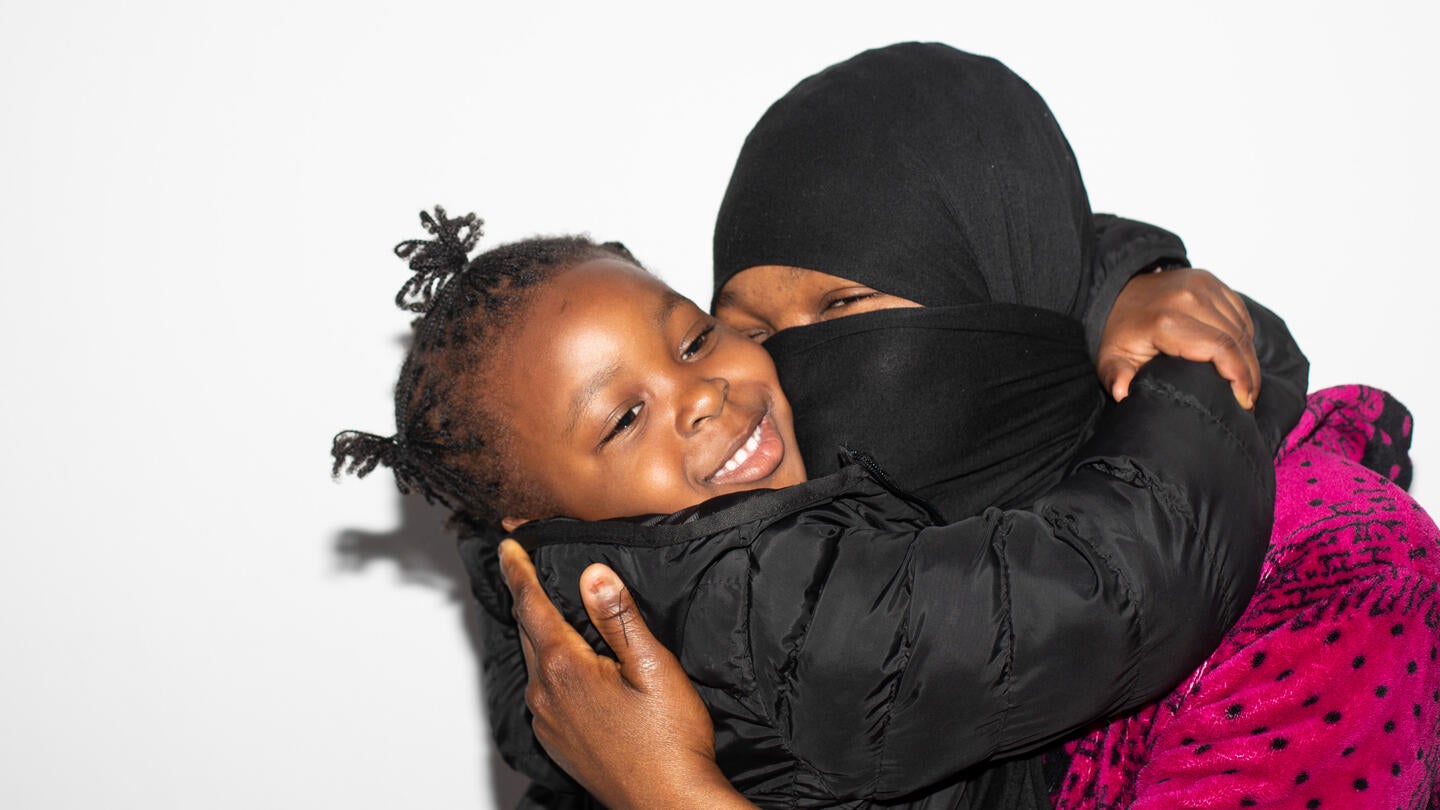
[[714, 43, 1092, 314]]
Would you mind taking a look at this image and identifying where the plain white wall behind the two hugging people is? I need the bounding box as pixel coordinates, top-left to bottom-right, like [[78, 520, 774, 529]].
[[0, 0, 1440, 810]]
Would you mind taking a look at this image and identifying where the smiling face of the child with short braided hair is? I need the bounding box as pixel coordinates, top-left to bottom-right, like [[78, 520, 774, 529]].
[[494, 259, 805, 529]]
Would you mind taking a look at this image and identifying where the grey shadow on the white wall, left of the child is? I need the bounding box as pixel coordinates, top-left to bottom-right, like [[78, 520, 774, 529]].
[[334, 494, 528, 807]]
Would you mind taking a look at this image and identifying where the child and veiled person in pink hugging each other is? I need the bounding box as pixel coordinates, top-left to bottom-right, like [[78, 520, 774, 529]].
[[334, 43, 1440, 807]]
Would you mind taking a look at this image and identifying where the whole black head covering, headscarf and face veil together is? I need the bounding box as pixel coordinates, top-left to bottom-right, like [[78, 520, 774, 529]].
[[714, 43, 1102, 519]]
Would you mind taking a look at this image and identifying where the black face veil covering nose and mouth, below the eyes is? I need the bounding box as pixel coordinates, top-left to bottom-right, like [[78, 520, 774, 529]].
[[766, 304, 1100, 520]]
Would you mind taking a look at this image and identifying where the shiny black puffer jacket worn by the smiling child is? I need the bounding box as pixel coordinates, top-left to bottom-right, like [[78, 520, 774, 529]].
[[468, 357, 1273, 807]]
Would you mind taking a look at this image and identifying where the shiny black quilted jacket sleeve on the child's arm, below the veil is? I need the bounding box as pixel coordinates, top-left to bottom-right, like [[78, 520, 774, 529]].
[[755, 357, 1274, 801]]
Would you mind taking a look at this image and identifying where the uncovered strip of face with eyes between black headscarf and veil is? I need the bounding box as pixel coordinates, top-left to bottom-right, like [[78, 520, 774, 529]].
[[716, 265, 920, 343]]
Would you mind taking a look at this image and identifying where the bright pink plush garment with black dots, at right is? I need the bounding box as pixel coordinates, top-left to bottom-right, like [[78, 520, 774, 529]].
[[1053, 386, 1440, 810]]
